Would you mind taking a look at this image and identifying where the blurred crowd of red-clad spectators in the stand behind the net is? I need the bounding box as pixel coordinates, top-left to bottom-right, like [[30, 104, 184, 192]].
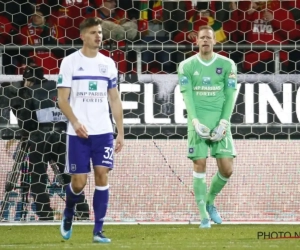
[[0, 0, 300, 74]]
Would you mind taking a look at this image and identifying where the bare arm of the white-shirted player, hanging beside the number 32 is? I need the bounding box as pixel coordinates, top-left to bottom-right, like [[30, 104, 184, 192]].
[[108, 88, 124, 153]]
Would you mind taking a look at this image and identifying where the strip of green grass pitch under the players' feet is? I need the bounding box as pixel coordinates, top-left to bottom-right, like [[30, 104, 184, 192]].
[[0, 224, 300, 250]]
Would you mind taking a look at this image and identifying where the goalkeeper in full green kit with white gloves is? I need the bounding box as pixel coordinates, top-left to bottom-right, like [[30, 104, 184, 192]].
[[178, 26, 237, 228]]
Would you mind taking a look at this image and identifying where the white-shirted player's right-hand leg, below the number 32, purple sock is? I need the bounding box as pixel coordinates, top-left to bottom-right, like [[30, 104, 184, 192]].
[[93, 166, 111, 243]]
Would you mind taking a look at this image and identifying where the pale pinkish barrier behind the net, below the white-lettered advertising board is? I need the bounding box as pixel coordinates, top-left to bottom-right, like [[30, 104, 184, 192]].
[[0, 139, 300, 222]]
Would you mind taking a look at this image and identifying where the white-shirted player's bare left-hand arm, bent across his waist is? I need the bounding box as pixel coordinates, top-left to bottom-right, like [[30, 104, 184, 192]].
[[57, 88, 88, 138]]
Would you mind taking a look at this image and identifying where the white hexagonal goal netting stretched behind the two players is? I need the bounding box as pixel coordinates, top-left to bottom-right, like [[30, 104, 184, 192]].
[[0, 0, 300, 222]]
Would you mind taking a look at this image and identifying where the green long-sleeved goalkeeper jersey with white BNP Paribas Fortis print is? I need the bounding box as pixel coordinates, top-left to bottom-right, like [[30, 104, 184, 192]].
[[178, 53, 237, 129]]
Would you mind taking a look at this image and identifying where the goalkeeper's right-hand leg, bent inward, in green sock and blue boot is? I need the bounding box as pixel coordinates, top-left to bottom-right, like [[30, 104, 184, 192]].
[[207, 158, 233, 224]]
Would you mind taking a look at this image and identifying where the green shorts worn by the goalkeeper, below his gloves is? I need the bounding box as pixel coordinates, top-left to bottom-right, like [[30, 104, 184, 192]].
[[188, 130, 236, 160]]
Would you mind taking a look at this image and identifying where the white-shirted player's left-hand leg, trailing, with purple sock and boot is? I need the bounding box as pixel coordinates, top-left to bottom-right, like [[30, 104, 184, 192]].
[[60, 174, 87, 240]]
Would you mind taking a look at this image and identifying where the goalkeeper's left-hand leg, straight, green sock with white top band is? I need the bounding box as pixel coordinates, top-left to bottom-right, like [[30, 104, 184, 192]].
[[193, 158, 210, 228]]
